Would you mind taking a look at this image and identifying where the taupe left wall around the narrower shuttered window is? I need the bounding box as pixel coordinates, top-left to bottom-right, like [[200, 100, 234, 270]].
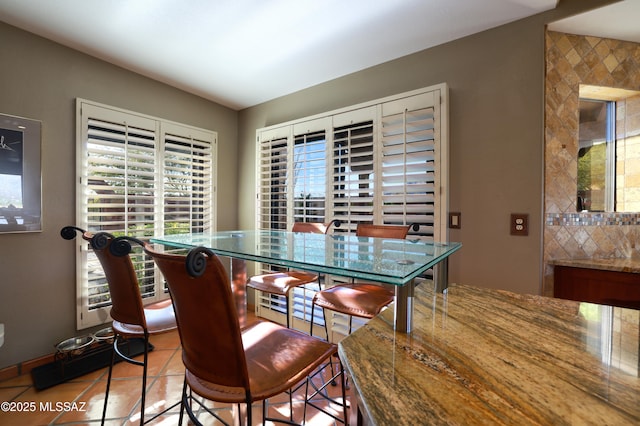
[[0, 23, 237, 369]]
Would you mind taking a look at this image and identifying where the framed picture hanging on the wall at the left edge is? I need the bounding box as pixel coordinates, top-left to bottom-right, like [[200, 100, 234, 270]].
[[0, 114, 42, 233]]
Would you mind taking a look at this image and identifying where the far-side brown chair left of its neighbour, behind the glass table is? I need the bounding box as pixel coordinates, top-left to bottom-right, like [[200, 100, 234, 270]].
[[247, 220, 340, 328]]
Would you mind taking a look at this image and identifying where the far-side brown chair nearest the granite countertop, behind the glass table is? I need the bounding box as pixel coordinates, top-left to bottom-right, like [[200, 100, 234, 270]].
[[310, 223, 420, 340]]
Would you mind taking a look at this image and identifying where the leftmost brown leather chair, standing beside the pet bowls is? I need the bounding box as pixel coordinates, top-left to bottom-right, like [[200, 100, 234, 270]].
[[60, 226, 180, 425]]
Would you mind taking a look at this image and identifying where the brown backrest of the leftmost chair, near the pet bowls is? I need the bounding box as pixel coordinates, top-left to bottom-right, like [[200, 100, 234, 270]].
[[60, 227, 147, 330]]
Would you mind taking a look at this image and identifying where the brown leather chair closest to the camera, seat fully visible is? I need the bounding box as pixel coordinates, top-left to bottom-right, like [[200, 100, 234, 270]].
[[145, 244, 346, 425]]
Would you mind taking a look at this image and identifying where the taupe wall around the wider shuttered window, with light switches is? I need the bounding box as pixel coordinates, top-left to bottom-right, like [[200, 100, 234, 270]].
[[238, 1, 616, 302]]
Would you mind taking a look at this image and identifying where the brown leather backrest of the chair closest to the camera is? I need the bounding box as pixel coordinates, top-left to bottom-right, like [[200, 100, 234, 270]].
[[144, 244, 249, 392]]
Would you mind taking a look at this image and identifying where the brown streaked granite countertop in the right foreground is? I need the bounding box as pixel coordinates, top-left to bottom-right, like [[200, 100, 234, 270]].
[[339, 284, 640, 425]]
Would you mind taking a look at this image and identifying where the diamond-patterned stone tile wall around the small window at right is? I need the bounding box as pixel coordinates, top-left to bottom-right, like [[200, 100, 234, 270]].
[[543, 31, 640, 295]]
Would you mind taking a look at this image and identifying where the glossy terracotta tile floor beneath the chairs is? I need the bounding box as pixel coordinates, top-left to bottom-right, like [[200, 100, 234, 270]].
[[0, 324, 350, 426]]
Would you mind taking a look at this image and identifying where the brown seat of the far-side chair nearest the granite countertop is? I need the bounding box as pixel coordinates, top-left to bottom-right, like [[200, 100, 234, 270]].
[[314, 284, 394, 318]]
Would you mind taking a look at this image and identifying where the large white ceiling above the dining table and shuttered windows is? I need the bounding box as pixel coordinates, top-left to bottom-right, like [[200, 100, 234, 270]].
[[0, 0, 608, 109]]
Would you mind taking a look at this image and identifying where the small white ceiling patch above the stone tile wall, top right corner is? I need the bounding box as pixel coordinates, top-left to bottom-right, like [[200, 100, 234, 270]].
[[549, 0, 640, 43]]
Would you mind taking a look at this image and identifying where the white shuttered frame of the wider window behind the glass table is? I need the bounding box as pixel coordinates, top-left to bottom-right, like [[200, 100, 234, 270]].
[[255, 83, 449, 341]]
